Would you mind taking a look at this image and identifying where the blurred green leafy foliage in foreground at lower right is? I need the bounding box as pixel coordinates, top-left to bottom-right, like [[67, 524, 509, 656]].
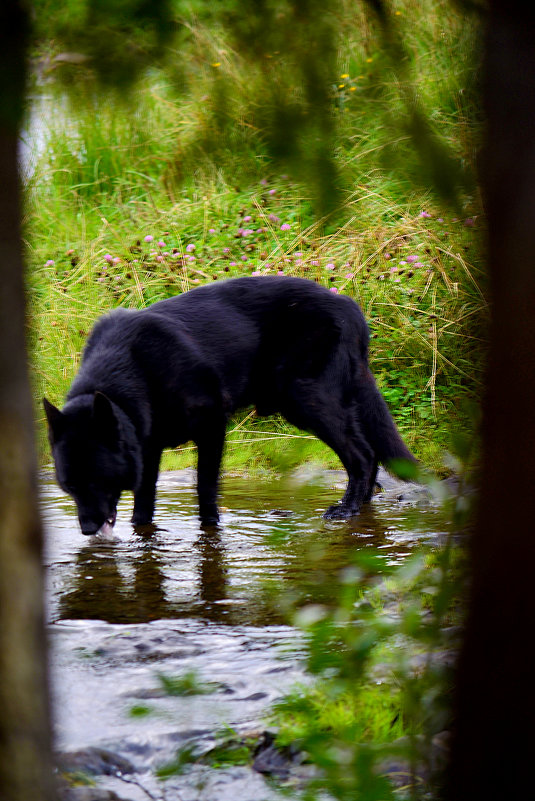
[[272, 542, 463, 801]]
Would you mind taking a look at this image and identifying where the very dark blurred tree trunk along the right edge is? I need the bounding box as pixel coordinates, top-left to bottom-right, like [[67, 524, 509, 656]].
[[447, 0, 535, 801]]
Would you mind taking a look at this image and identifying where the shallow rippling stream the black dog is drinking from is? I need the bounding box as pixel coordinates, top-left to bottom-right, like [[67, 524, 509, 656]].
[[42, 467, 448, 801]]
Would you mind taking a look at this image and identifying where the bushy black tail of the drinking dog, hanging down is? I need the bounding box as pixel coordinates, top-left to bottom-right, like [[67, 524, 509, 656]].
[[358, 370, 417, 478]]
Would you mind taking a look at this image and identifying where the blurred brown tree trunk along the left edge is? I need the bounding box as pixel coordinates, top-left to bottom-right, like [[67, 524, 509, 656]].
[[0, 0, 55, 801]]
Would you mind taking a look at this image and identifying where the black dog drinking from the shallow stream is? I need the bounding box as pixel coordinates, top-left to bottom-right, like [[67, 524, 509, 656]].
[[44, 277, 414, 534]]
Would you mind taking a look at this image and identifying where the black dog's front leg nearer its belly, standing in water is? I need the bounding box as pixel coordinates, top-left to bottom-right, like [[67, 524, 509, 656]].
[[195, 419, 226, 526]]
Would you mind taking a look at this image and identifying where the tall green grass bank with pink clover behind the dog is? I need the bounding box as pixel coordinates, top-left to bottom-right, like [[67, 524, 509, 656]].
[[25, 0, 487, 470]]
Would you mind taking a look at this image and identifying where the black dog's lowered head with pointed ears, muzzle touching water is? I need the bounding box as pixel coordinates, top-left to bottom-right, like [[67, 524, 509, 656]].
[[43, 392, 136, 534]]
